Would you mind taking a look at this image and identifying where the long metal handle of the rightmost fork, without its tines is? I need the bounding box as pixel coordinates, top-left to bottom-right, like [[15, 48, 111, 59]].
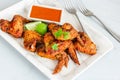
[[92, 15, 120, 43]]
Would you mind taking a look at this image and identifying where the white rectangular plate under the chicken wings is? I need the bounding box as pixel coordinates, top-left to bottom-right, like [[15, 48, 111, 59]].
[[0, 0, 113, 80]]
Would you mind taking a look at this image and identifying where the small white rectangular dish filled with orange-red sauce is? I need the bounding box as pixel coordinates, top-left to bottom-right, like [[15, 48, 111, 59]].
[[29, 5, 62, 22]]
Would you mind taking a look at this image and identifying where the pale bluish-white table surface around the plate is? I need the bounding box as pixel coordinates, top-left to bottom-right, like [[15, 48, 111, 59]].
[[0, 0, 120, 80]]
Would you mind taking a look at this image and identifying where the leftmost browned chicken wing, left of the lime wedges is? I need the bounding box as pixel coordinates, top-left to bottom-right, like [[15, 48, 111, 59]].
[[0, 15, 29, 38]]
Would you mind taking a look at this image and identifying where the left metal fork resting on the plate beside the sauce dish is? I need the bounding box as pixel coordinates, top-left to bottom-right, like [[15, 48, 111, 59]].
[[63, 0, 87, 33]]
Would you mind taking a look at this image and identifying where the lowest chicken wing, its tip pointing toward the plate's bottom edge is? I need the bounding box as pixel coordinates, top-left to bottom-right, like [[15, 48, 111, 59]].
[[37, 45, 69, 74]]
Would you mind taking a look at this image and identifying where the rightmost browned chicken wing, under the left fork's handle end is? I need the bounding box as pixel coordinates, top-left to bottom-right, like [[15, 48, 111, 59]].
[[74, 32, 96, 55]]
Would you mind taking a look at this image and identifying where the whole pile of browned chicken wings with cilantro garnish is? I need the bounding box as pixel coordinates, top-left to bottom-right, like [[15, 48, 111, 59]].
[[0, 15, 96, 74]]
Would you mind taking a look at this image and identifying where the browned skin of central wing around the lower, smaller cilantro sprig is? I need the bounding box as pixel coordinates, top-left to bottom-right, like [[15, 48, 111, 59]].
[[44, 32, 71, 55]]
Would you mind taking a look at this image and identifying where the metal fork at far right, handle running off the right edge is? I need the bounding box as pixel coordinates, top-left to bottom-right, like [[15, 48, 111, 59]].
[[74, 0, 120, 42]]
